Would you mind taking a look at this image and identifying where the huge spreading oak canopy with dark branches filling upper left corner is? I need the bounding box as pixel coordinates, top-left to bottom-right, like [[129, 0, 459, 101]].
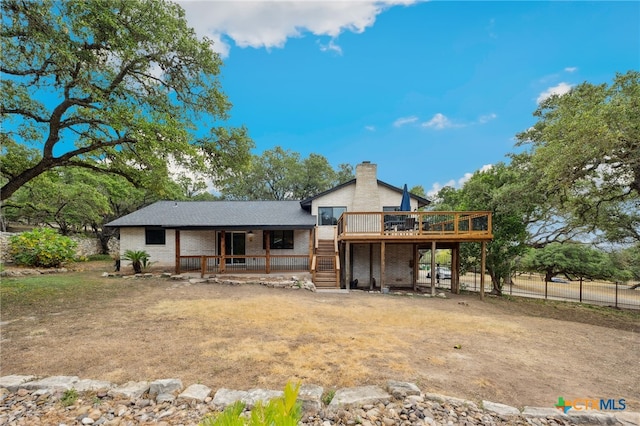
[[0, 0, 253, 200]]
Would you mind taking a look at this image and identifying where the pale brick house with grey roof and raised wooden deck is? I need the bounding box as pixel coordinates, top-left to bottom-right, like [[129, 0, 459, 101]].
[[107, 162, 492, 291]]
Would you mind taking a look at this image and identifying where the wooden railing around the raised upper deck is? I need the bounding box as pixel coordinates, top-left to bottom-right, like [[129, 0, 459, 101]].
[[338, 211, 492, 239]]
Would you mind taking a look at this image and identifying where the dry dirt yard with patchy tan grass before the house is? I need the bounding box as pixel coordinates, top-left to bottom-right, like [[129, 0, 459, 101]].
[[0, 272, 640, 411]]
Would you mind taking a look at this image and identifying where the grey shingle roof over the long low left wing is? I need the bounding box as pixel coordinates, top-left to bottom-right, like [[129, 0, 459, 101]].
[[106, 201, 316, 229]]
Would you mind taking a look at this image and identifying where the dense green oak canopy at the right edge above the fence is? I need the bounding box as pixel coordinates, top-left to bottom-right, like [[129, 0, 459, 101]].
[[517, 71, 640, 242]]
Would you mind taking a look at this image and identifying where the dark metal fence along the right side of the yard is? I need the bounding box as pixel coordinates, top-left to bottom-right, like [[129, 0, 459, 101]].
[[419, 272, 640, 309]]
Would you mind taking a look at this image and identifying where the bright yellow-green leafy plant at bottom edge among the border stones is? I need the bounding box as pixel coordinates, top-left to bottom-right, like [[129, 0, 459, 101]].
[[200, 382, 302, 426]]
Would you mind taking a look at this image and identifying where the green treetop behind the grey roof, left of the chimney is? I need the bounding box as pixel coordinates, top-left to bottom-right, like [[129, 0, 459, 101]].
[[220, 146, 353, 200]]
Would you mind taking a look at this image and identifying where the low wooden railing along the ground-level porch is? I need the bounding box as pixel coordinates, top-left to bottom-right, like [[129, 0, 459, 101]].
[[177, 255, 310, 276]]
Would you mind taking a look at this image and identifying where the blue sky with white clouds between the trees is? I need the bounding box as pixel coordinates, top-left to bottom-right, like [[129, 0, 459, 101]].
[[180, 0, 640, 192]]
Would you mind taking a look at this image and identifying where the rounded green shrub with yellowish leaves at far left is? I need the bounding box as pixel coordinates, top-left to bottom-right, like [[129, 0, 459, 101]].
[[9, 228, 77, 268]]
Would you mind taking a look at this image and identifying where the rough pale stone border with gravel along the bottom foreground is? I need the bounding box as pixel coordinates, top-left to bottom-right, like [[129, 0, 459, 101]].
[[0, 375, 640, 426]]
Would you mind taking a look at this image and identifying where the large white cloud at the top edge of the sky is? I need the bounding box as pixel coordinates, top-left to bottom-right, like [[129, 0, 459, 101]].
[[179, 0, 419, 57]]
